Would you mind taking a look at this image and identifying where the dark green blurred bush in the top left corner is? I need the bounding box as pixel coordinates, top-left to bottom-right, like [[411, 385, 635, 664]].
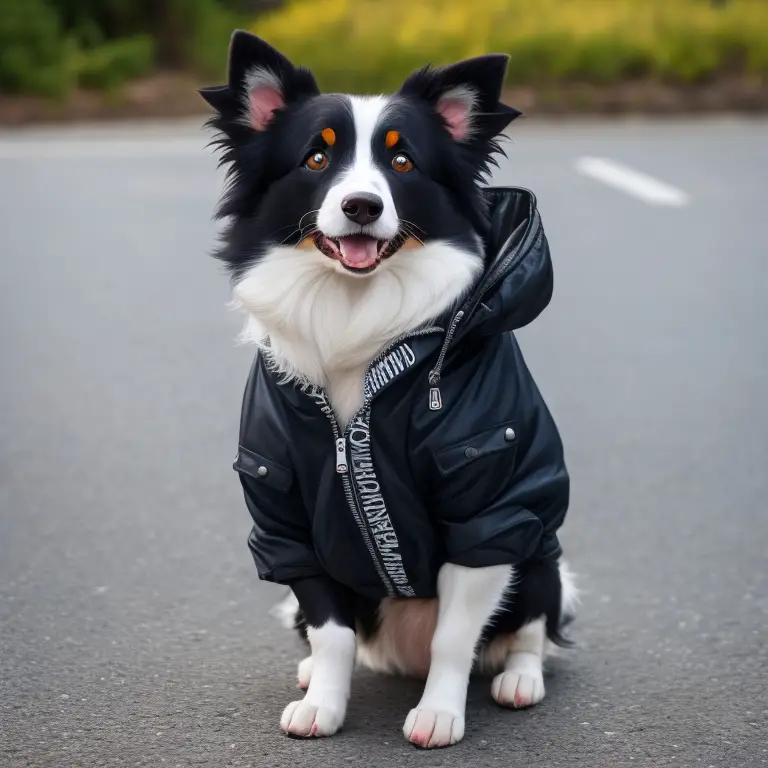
[[0, 0, 243, 97]]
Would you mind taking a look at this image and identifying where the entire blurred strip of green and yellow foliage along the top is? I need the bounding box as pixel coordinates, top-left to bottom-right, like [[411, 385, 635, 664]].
[[0, 0, 768, 98]]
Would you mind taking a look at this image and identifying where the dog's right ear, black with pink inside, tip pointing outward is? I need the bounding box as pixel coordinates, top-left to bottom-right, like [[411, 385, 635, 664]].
[[400, 54, 522, 141]]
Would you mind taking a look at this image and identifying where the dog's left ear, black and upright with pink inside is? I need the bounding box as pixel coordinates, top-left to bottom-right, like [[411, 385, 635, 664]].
[[199, 29, 320, 131]]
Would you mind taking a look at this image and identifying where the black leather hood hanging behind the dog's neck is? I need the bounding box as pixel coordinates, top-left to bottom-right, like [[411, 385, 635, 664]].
[[454, 187, 553, 340]]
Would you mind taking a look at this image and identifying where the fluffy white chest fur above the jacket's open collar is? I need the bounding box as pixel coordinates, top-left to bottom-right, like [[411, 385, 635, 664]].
[[234, 242, 482, 426]]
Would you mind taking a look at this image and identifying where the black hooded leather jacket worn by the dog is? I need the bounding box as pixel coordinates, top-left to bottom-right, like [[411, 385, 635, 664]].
[[234, 188, 569, 598]]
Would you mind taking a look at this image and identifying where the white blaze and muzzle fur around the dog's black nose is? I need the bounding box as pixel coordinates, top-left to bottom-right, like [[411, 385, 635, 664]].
[[317, 96, 399, 240]]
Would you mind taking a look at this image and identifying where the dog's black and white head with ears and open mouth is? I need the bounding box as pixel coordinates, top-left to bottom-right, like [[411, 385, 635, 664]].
[[201, 31, 519, 278]]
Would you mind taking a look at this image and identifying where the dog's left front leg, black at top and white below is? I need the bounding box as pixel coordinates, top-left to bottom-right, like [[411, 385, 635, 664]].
[[280, 577, 356, 736]]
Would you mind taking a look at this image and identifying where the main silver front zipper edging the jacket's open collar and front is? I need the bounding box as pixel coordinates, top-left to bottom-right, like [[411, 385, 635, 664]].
[[306, 325, 440, 597]]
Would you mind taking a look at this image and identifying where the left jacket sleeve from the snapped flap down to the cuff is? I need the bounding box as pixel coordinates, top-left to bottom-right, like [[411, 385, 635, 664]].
[[234, 445, 324, 584]]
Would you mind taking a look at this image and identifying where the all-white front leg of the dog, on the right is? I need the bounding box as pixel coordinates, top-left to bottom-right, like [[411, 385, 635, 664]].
[[403, 563, 512, 747]]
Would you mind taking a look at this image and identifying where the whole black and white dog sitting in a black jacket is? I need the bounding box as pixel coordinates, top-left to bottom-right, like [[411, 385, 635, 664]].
[[201, 32, 576, 747]]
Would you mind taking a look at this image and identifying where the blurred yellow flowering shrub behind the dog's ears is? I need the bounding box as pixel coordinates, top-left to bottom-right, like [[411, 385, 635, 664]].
[[252, 0, 768, 91]]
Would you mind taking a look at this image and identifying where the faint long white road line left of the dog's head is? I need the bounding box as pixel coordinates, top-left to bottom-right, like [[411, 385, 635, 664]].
[[0, 136, 207, 160]]
